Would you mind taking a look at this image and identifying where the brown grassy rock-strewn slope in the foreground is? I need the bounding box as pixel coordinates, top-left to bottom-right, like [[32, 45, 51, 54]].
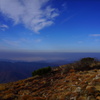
[[0, 58, 100, 100]]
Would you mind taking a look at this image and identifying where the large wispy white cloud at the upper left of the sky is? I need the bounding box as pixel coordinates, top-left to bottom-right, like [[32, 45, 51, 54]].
[[0, 0, 59, 33]]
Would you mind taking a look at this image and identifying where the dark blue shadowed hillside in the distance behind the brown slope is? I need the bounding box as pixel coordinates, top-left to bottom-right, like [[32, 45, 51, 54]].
[[0, 61, 61, 83]]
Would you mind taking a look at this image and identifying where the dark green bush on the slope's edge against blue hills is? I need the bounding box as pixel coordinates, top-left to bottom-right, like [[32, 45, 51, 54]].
[[32, 66, 51, 76]]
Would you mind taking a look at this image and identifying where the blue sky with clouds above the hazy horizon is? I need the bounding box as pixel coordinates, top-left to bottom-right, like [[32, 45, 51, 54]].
[[0, 0, 100, 61]]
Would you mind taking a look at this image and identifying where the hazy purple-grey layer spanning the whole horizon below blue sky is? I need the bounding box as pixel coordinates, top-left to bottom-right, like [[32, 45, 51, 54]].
[[0, 50, 100, 62]]
